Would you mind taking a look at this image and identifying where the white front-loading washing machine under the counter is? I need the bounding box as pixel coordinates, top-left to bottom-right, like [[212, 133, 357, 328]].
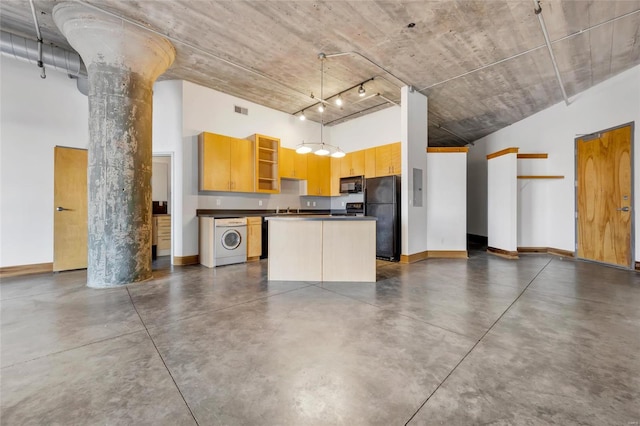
[[213, 217, 247, 266]]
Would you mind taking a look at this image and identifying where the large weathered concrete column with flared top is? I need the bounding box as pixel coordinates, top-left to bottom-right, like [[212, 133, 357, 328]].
[[53, 3, 175, 287]]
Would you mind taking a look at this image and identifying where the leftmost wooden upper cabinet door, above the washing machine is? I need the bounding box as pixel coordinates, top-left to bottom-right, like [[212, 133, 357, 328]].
[[200, 133, 231, 191]]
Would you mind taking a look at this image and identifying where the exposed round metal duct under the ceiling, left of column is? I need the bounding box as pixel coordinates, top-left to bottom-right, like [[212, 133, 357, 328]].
[[0, 31, 88, 95]]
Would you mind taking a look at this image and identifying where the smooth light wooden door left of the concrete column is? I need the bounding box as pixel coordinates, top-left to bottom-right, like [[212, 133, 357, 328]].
[[53, 146, 87, 271]]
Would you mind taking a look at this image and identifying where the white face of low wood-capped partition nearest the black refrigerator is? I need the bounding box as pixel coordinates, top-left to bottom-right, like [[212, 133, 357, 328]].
[[426, 152, 467, 251]]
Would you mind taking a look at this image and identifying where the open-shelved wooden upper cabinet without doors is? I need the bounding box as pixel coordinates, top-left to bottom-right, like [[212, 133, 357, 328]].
[[248, 134, 280, 193]]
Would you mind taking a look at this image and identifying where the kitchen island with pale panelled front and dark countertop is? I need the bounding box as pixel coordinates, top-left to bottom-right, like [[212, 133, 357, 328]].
[[265, 215, 376, 282]]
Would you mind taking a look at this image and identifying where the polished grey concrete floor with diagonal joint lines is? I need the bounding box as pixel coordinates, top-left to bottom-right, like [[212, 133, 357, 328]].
[[0, 252, 640, 425]]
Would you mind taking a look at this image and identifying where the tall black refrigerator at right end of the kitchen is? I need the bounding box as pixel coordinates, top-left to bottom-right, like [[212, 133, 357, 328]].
[[364, 176, 400, 262]]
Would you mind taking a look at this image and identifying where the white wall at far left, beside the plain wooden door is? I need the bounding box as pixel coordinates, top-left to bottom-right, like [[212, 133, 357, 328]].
[[0, 56, 89, 267]]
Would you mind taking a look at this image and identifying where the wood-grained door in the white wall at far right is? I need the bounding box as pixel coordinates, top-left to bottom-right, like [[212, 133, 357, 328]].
[[576, 125, 633, 267]]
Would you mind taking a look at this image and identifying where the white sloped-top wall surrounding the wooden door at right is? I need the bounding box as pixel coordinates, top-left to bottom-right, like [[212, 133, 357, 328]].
[[468, 66, 640, 261]]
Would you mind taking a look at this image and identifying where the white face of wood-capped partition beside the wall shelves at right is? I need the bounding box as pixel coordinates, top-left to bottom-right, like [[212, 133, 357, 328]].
[[487, 153, 518, 252]]
